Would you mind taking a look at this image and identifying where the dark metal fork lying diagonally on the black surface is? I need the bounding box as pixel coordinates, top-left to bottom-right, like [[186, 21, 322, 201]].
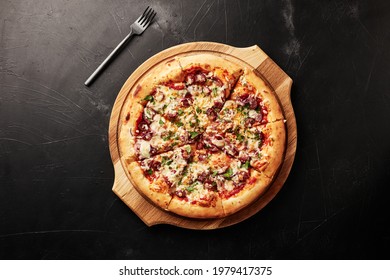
[[84, 6, 157, 86]]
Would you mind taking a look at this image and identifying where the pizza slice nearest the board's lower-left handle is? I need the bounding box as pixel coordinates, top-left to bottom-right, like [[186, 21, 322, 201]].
[[128, 145, 192, 209]]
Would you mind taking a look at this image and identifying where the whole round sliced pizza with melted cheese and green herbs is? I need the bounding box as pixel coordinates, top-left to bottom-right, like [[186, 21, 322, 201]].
[[118, 54, 286, 218]]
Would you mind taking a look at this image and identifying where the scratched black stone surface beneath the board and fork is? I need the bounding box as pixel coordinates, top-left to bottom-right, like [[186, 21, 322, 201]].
[[0, 0, 390, 259]]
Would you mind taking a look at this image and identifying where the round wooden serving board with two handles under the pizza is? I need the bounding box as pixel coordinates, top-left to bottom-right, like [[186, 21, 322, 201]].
[[109, 42, 297, 229]]
